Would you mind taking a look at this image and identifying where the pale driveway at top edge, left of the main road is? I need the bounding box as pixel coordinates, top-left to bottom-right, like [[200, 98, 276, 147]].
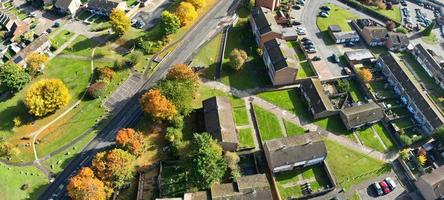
[[132, 0, 174, 30]]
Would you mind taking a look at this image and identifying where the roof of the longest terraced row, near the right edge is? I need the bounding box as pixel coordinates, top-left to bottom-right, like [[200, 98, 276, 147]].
[[380, 52, 444, 128]]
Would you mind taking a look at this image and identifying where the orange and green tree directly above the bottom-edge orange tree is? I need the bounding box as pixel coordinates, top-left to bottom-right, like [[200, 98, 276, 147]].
[[91, 149, 135, 189]]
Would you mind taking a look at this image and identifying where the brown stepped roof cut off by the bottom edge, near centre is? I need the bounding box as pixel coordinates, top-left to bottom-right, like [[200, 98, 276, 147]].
[[211, 174, 273, 200]]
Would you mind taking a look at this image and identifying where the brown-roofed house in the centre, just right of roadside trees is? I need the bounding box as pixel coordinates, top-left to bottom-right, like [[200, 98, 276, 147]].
[[202, 96, 239, 151]]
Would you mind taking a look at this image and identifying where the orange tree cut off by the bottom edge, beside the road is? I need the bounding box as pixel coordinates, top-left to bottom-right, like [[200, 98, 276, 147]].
[[67, 167, 110, 200]]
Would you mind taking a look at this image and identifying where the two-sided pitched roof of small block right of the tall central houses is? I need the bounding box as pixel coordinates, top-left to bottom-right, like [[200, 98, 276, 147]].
[[301, 78, 334, 113]]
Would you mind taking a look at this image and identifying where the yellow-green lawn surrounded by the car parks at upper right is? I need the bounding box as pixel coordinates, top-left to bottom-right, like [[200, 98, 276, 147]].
[[316, 3, 358, 45]]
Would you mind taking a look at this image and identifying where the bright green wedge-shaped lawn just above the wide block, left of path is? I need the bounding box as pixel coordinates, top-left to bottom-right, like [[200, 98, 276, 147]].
[[254, 105, 284, 142]]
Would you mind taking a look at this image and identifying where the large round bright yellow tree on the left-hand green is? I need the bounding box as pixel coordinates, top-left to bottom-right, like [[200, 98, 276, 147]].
[[24, 79, 71, 117]]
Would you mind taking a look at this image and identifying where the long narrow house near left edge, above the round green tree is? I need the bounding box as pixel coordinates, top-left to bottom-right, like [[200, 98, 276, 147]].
[[11, 33, 51, 64]]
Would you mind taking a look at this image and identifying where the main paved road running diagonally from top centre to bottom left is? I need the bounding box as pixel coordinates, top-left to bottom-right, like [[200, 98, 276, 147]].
[[39, 0, 237, 200]]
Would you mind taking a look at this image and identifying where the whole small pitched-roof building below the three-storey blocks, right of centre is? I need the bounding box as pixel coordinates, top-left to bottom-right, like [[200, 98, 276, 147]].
[[300, 78, 336, 119]]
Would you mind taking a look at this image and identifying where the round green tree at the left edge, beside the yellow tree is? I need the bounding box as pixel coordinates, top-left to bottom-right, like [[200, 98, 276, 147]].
[[0, 63, 31, 92]]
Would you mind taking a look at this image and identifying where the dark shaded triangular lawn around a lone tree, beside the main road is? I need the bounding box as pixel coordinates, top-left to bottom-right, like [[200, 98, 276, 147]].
[[220, 7, 271, 89]]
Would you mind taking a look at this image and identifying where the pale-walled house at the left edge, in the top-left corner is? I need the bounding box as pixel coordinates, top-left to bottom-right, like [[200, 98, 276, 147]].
[[0, 9, 29, 41]]
